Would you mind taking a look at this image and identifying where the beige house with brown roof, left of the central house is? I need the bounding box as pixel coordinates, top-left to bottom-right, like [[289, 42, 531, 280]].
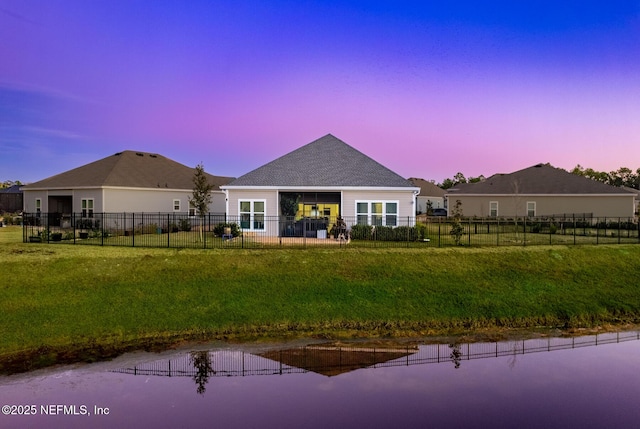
[[22, 150, 232, 226]]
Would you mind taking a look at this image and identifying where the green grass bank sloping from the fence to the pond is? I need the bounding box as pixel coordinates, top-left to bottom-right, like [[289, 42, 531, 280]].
[[0, 227, 640, 370]]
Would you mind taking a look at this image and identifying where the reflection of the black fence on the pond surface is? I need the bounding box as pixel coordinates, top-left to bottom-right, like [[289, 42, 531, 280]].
[[114, 331, 640, 377]]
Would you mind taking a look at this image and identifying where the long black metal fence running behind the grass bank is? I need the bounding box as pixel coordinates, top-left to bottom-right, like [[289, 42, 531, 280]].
[[23, 213, 640, 248]]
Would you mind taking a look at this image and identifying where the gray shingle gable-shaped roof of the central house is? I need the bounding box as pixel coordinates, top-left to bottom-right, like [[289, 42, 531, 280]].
[[228, 134, 413, 188]]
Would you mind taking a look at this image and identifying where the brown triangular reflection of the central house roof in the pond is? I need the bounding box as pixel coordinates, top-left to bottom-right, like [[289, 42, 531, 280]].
[[258, 345, 418, 377]]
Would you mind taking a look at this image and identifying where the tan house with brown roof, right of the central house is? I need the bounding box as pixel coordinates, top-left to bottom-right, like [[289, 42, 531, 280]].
[[447, 164, 635, 218]]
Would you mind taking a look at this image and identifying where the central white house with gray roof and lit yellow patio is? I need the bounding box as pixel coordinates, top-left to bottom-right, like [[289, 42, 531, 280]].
[[221, 134, 420, 237]]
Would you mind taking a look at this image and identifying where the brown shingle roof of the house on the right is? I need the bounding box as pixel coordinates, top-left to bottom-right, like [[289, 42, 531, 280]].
[[448, 164, 627, 195]]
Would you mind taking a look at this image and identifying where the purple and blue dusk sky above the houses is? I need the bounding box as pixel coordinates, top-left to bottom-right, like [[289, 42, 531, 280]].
[[0, 0, 640, 183]]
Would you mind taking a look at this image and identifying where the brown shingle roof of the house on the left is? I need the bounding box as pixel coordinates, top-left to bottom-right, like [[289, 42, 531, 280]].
[[22, 150, 233, 190]]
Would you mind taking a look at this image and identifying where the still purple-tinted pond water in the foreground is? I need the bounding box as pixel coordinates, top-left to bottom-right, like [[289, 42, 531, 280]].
[[0, 331, 640, 429]]
